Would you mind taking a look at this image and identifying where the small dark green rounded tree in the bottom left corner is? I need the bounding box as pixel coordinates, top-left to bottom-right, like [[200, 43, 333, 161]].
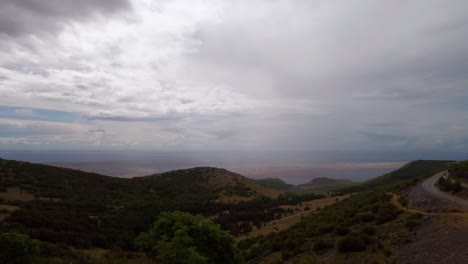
[[0, 233, 40, 264]]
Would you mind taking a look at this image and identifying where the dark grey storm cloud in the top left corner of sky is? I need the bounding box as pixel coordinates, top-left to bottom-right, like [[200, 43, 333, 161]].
[[0, 0, 130, 36]]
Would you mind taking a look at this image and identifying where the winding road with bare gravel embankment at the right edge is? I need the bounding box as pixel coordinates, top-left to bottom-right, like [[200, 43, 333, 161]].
[[396, 172, 468, 264]]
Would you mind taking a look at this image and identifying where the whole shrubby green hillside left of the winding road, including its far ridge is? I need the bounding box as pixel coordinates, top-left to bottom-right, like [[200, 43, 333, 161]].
[[239, 161, 454, 263]]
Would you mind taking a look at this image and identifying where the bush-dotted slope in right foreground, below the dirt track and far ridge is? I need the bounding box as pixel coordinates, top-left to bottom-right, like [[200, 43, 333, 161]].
[[239, 191, 419, 263]]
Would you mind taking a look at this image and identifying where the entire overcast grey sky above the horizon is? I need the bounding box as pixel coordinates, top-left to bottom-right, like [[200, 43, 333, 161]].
[[0, 0, 468, 151]]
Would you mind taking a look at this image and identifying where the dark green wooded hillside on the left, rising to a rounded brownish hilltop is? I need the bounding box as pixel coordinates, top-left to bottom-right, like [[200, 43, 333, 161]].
[[0, 160, 282, 250]]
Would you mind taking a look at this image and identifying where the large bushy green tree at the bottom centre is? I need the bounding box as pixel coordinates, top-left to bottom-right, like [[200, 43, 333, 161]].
[[135, 211, 242, 264]]
